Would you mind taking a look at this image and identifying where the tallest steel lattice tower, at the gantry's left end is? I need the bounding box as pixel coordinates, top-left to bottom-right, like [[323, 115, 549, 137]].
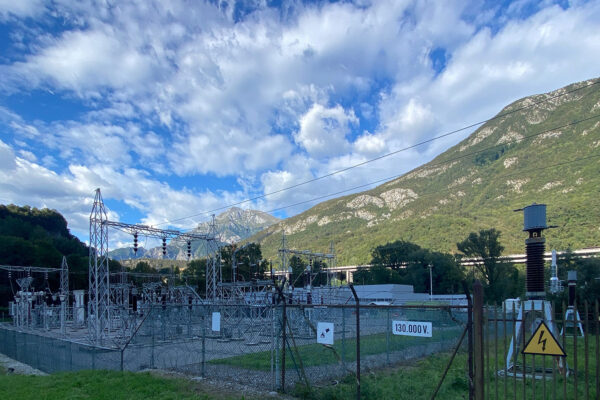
[[88, 189, 110, 342]]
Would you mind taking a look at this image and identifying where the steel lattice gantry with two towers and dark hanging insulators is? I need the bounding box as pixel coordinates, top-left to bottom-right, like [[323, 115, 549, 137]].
[[87, 189, 219, 343]]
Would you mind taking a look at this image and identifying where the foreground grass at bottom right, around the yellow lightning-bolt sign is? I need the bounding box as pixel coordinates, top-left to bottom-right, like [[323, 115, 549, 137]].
[[295, 336, 598, 400]]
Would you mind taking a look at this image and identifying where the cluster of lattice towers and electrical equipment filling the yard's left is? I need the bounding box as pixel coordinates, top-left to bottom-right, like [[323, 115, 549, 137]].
[[0, 189, 339, 347]]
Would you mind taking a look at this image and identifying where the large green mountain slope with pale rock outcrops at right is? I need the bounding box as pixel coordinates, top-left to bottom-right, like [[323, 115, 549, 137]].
[[250, 79, 600, 265]]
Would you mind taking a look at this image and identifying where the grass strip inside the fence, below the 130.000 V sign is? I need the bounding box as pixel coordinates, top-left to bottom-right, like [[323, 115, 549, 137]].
[[210, 327, 462, 371]]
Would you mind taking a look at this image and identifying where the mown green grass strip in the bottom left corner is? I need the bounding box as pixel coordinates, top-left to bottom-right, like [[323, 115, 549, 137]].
[[0, 371, 255, 400]]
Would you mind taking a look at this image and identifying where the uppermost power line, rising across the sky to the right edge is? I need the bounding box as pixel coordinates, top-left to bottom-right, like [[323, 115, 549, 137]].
[[156, 80, 600, 226]]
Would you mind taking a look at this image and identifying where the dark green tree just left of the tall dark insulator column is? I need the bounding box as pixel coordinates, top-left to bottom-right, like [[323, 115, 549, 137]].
[[456, 228, 519, 304]]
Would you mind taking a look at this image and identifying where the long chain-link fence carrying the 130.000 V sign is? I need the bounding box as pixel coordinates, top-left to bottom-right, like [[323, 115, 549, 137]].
[[0, 303, 467, 391]]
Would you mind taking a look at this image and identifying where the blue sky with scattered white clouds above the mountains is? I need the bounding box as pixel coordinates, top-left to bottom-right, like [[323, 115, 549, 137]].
[[0, 0, 600, 246]]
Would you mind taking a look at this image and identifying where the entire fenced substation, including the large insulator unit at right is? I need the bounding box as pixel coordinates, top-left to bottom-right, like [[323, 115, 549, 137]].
[[0, 194, 598, 396]]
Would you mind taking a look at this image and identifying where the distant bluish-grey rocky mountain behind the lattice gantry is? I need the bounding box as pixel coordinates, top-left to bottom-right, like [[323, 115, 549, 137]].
[[108, 207, 279, 260]]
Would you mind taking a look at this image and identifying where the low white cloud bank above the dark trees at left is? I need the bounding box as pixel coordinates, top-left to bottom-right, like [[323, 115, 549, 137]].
[[0, 141, 243, 235]]
